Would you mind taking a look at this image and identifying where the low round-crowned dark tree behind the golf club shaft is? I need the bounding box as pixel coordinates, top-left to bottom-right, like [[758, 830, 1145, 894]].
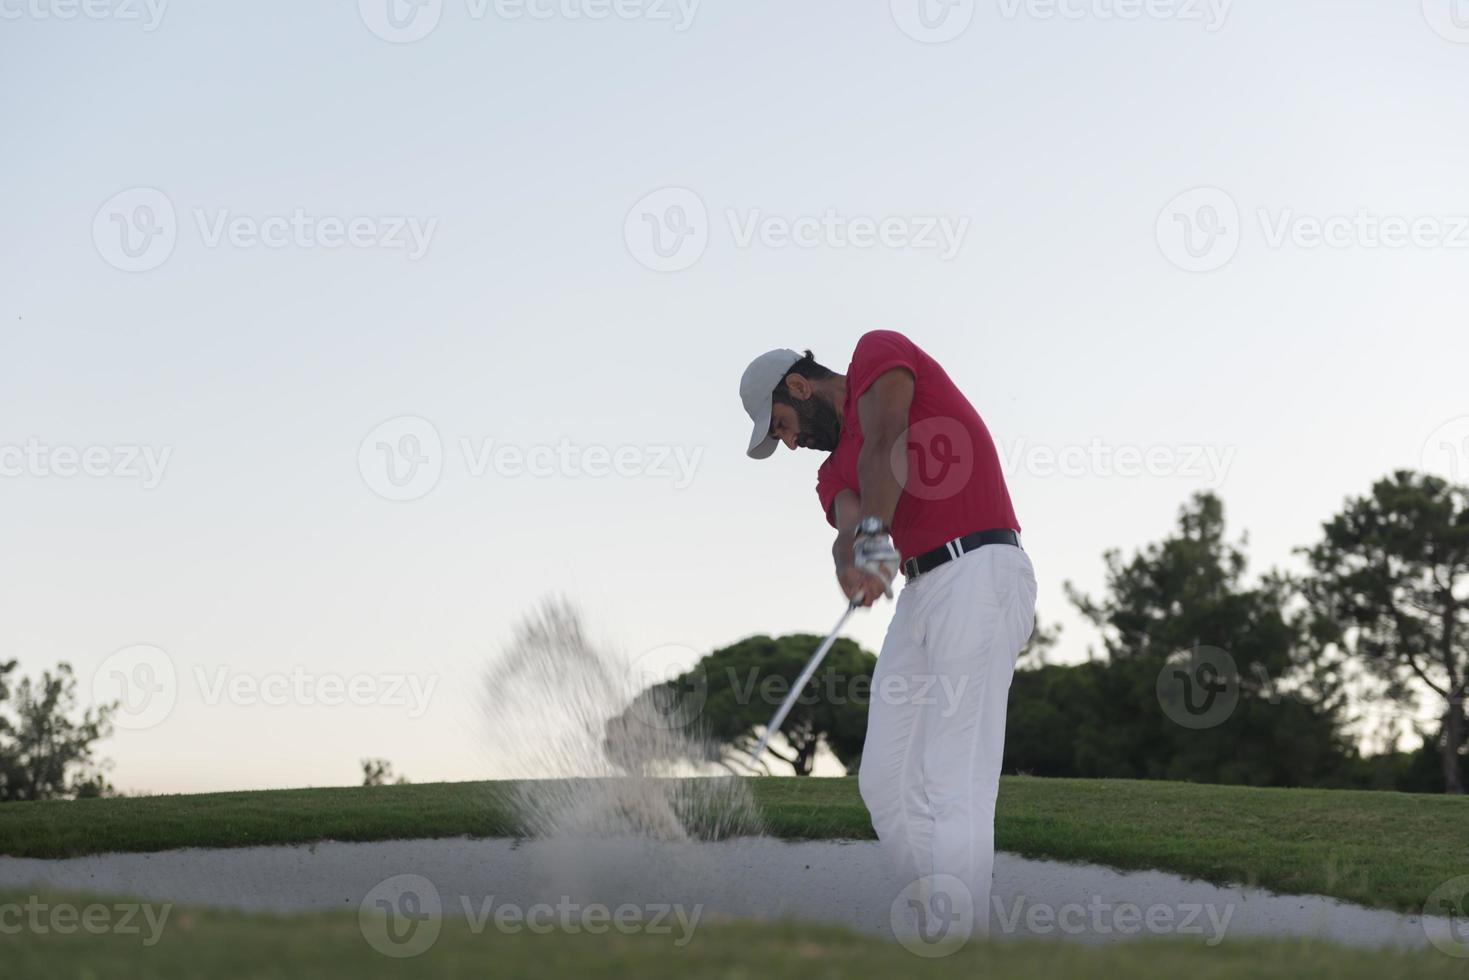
[[607, 633, 877, 776]]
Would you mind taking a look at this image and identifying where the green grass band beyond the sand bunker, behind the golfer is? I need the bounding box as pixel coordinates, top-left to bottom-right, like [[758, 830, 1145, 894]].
[[0, 777, 1469, 911]]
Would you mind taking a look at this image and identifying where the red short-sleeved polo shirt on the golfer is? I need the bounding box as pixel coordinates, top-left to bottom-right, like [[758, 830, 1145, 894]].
[[817, 331, 1019, 561]]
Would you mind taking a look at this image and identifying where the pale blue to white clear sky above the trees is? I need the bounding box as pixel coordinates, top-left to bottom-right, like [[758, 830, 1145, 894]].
[[0, 0, 1469, 792]]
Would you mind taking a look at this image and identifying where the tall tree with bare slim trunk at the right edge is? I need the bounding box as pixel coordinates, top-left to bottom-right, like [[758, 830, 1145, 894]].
[[1303, 470, 1469, 793]]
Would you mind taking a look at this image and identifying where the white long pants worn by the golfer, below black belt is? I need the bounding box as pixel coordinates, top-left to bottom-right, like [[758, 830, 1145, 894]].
[[858, 545, 1036, 934]]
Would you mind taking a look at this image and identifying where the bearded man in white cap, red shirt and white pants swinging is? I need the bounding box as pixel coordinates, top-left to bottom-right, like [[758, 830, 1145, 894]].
[[740, 331, 1036, 934]]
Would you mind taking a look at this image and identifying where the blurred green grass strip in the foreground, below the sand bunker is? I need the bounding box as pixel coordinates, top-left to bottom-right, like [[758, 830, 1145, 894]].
[[0, 893, 1465, 980]]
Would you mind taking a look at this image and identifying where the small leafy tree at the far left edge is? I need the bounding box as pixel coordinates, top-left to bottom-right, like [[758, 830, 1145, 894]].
[[0, 661, 116, 801]]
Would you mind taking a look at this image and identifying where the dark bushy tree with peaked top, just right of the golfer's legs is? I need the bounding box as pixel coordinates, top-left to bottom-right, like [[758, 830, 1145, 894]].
[[1045, 494, 1351, 786]]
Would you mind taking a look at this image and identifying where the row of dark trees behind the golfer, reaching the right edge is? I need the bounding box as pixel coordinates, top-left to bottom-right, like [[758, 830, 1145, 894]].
[[608, 470, 1469, 793]]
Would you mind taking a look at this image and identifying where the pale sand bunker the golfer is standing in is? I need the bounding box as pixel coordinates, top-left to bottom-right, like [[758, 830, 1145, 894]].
[[0, 837, 1447, 946]]
